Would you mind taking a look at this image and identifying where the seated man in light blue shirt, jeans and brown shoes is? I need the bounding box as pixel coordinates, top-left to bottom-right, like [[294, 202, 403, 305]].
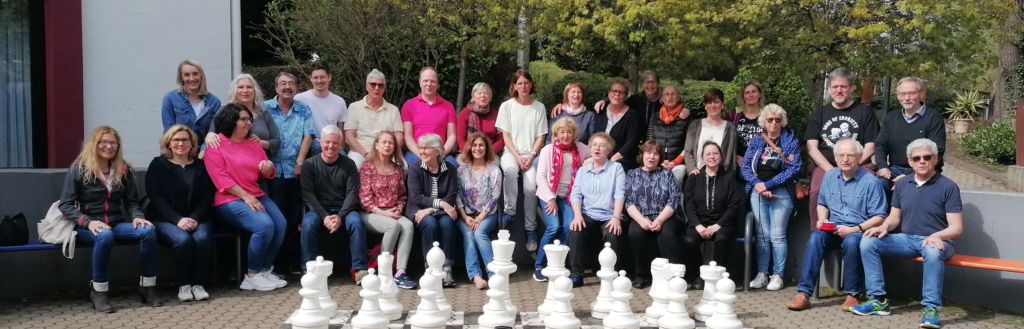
[[785, 139, 886, 311]]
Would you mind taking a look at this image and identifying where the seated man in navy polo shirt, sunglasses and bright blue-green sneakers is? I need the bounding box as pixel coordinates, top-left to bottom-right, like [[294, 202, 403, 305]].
[[852, 138, 964, 328]]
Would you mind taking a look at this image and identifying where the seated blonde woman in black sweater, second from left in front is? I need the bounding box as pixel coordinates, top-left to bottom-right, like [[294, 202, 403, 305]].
[[145, 124, 216, 301]]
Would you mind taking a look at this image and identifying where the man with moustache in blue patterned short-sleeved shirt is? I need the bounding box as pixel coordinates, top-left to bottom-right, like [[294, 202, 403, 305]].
[[263, 72, 313, 274]]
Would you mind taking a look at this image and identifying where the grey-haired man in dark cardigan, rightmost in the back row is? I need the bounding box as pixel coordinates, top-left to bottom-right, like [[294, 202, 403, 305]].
[[874, 77, 946, 200]]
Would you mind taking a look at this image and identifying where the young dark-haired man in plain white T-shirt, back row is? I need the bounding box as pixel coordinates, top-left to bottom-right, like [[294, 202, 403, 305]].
[[295, 60, 348, 155]]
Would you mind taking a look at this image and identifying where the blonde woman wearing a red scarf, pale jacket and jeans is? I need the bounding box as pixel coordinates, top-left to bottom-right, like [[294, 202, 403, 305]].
[[534, 118, 590, 282]]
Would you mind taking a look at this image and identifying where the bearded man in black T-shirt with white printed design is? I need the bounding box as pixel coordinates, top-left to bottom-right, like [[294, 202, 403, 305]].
[[804, 68, 879, 227]]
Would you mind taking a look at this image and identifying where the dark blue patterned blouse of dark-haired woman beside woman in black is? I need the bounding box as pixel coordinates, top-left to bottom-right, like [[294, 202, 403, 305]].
[[626, 167, 680, 219]]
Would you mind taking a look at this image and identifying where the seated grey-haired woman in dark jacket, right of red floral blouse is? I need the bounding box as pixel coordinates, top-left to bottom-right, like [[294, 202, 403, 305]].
[[406, 133, 459, 288]]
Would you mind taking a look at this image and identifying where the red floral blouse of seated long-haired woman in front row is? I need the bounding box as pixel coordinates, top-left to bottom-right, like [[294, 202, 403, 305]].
[[359, 161, 407, 211]]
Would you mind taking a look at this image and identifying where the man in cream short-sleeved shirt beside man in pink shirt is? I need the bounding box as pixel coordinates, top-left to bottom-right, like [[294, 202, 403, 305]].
[[345, 69, 406, 168]]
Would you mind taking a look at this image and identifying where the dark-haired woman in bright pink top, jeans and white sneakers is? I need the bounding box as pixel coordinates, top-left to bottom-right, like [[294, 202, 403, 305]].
[[204, 102, 288, 291]]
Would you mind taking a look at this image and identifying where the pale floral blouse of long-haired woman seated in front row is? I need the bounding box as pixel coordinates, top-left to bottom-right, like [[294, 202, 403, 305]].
[[456, 164, 502, 215]]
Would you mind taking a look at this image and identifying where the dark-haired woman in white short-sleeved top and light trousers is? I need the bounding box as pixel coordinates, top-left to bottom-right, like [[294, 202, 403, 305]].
[[495, 70, 548, 251]]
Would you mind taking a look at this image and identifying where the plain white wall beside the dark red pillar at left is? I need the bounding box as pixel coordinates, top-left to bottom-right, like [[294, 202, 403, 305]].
[[82, 0, 232, 167]]
